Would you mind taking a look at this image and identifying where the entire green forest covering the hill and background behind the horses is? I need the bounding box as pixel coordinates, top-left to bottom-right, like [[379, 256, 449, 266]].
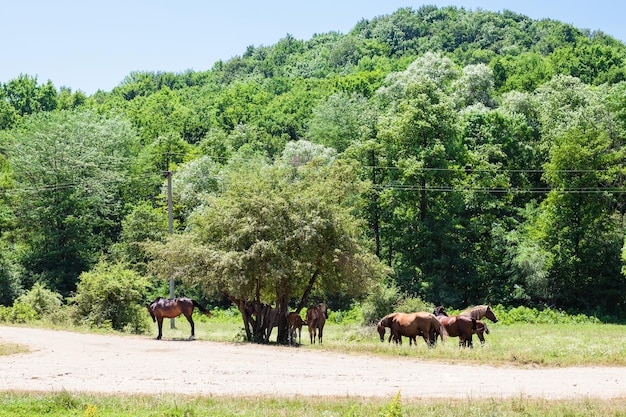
[[0, 6, 626, 340]]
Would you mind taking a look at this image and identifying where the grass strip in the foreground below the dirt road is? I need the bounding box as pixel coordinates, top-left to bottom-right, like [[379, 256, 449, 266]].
[[0, 392, 626, 417]]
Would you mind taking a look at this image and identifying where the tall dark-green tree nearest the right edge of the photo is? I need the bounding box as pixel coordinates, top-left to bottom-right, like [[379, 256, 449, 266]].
[[539, 128, 626, 314]]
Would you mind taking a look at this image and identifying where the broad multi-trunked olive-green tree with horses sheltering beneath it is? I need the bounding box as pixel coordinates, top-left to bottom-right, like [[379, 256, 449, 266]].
[[152, 153, 383, 343]]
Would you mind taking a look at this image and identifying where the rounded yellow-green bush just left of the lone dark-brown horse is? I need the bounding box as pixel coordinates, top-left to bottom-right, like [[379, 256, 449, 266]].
[[73, 262, 150, 333]]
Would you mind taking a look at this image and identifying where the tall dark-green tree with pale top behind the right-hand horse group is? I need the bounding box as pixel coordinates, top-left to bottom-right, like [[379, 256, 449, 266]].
[[370, 54, 464, 303]]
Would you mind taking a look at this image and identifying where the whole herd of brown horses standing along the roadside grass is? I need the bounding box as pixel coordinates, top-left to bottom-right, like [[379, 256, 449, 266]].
[[147, 297, 498, 347]]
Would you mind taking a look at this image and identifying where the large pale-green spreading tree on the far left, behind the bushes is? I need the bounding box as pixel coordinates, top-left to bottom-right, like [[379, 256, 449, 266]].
[[9, 111, 136, 294]]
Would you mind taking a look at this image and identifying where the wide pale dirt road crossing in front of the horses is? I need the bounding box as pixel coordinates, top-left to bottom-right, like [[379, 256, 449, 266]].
[[0, 327, 626, 399]]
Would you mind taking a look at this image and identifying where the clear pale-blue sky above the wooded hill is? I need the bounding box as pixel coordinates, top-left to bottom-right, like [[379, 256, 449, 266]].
[[0, 0, 626, 95]]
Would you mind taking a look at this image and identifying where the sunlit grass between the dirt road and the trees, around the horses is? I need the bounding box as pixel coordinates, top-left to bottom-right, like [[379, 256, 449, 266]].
[[145, 317, 626, 367]]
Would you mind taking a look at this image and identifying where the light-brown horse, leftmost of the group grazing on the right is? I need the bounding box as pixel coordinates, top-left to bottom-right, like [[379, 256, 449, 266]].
[[377, 311, 447, 347]]
